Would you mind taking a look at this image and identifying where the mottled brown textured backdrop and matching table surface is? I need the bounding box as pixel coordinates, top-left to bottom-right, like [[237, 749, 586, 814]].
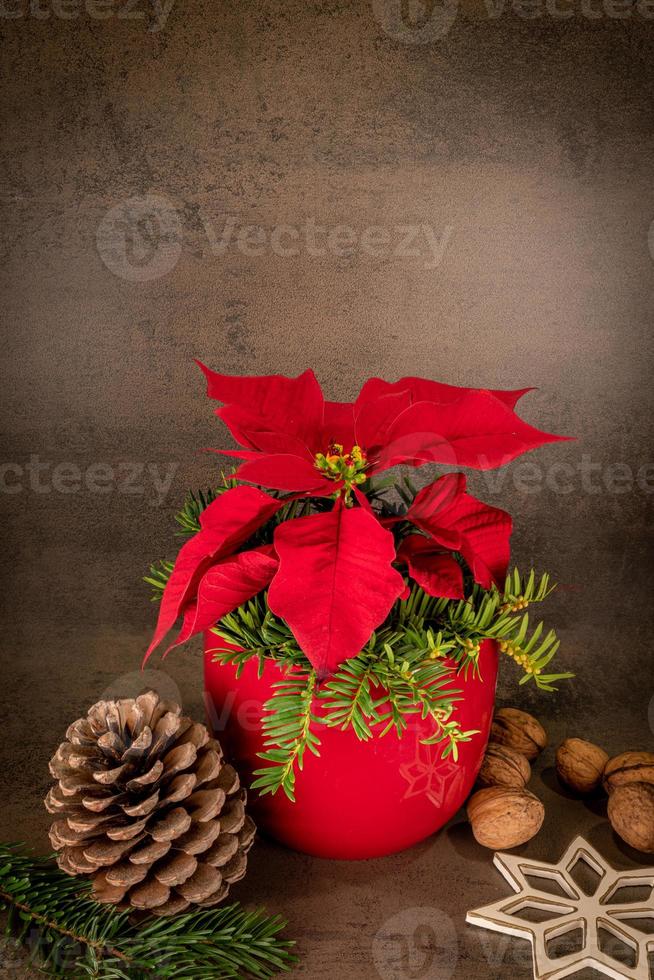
[[0, 0, 654, 980]]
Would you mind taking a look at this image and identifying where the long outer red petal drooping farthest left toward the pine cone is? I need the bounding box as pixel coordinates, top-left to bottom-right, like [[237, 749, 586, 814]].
[[145, 487, 283, 660]]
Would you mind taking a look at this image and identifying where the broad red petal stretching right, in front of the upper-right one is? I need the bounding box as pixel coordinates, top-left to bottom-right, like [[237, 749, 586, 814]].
[[373, 391, 567, 472]]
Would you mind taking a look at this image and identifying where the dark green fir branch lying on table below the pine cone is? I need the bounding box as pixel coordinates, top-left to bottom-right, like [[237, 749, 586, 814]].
[[0, 844, 295, 980]]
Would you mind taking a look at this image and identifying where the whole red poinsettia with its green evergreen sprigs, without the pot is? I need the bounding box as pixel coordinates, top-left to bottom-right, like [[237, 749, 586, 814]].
[[146, 362, 570, 796]]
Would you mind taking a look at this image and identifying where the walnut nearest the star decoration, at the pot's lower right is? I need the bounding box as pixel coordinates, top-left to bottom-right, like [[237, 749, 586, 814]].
[[467, 786, 545, 850]]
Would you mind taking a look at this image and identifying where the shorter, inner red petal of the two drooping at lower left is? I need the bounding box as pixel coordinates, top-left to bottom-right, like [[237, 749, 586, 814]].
[[164, 545, 279, 656]]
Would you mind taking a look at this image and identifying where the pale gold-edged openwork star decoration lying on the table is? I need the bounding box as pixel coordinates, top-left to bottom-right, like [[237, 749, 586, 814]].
[[466, 837, 654, 980]]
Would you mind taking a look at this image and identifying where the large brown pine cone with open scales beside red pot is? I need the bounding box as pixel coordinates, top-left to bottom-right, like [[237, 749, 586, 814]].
[[45, 691, 255, 915]]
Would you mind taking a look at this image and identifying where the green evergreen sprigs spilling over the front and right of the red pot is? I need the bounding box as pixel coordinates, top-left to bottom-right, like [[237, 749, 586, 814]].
[[202, 570, 572, 799]]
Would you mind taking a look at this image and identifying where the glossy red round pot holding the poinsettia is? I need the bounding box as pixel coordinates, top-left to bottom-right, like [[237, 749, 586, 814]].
[[205, 633, 498, 859]]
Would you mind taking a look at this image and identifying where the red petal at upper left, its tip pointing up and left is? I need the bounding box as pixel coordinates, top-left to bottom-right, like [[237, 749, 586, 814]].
[[196, 361, 324, 448]]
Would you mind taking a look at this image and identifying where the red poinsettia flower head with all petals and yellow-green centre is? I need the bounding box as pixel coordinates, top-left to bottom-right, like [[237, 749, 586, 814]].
[[146, 365, 564, 677]]
